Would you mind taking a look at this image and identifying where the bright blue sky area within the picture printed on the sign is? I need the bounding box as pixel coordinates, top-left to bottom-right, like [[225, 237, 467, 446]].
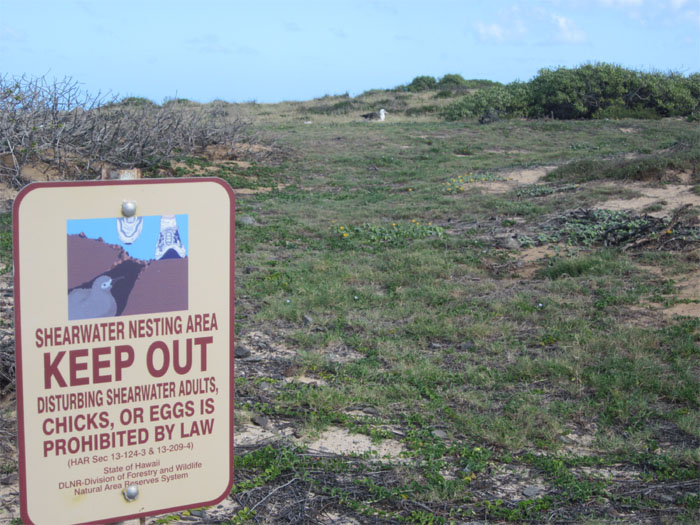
[[66, 215, 189, 261]]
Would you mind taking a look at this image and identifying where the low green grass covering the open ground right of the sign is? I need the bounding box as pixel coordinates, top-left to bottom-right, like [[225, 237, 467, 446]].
[[6, 91, 700, 524]]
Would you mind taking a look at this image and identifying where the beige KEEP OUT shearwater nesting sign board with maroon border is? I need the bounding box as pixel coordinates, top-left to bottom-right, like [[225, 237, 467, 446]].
[[14, 178, 234, 525]]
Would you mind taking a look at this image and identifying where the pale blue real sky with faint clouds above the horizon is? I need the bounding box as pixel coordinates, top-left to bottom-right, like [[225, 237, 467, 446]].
[[0, 0, 700, 103]]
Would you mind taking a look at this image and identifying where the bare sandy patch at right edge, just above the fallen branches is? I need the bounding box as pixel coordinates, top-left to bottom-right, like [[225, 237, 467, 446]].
[[595, 183, 700, 218]]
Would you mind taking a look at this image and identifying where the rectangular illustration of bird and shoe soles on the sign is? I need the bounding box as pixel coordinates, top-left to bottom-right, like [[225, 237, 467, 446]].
[[66, 214, 189, 321]]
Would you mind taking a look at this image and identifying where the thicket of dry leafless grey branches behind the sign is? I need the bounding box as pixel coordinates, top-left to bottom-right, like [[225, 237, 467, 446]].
[[0, 73, 255, 187]]
